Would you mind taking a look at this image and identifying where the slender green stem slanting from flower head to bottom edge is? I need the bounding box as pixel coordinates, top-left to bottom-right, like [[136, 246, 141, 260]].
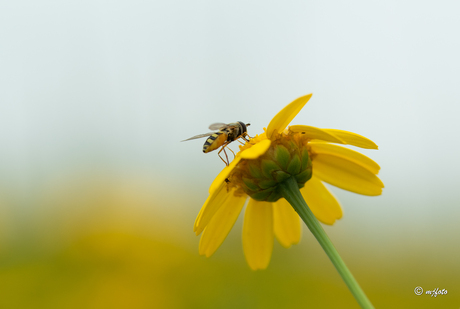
[[280, 177, 374, 308]]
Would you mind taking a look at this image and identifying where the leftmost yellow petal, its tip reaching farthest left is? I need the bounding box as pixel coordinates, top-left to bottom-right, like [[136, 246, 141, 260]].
[[193, 183, 233, 235]]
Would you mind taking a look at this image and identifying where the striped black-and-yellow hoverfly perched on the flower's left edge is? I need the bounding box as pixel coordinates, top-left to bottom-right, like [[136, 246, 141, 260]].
[[183, 121, 250, 165]]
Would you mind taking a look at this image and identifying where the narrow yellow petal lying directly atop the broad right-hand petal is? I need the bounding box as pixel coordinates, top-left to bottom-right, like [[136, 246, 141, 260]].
[[308, 142, 380, 174]]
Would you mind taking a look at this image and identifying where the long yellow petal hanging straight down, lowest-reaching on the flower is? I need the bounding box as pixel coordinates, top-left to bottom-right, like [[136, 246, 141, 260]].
[[243, 199, 273, 270]]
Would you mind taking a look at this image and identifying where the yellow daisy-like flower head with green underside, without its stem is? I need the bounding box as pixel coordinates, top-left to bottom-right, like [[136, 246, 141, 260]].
[[194, 94, 383, 270]]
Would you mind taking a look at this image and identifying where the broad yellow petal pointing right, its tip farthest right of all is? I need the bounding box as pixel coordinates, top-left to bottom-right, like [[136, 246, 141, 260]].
[[312, 154, 383, 196]]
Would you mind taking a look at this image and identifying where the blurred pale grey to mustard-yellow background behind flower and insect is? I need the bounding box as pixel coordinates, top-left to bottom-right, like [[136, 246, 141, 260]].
[[0, 0, 460, 308]]
